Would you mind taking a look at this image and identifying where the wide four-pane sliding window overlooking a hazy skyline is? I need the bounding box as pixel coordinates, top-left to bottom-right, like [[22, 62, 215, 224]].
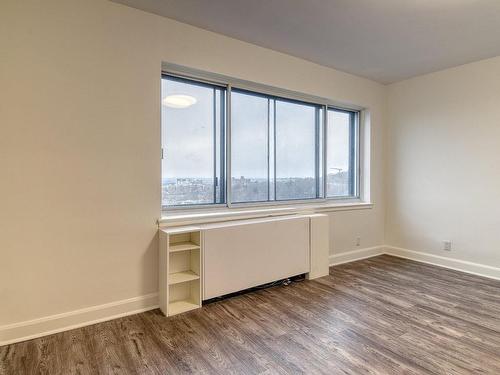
[[162, 75, 359, 208]]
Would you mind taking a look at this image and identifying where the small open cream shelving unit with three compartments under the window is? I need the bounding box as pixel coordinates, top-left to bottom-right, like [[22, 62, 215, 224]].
[[159, 227, 202, 316]]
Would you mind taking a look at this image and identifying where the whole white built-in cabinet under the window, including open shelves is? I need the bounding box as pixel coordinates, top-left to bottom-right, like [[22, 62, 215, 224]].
[[159, 214, 329, 316]]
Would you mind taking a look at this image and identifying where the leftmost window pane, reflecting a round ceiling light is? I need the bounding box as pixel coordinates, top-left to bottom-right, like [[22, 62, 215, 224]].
[[162, 77, 224, 206]]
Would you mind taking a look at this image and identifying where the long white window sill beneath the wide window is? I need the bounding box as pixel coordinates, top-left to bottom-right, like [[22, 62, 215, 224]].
[[158, 201, 373, 227]]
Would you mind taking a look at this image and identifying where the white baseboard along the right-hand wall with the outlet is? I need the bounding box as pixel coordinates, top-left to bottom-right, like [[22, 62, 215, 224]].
[[385, 246, 500, 280]]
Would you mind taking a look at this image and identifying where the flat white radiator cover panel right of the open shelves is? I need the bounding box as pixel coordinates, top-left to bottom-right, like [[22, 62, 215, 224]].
[[203, 216, 310, 300]]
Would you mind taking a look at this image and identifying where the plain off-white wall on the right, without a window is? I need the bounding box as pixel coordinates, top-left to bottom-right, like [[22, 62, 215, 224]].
[[386, 57, 500, 268]]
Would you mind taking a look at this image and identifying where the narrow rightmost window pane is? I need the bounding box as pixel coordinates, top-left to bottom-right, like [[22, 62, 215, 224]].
[[327, 109, 356, 197]]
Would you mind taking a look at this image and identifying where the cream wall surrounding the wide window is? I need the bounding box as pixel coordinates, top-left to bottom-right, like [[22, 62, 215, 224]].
[[0, 0, 385, 334]]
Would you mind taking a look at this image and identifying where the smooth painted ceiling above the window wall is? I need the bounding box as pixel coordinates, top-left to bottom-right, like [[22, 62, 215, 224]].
[[113, 0, 500, 83]]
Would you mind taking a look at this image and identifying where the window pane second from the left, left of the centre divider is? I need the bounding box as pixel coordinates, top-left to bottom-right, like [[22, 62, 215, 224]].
[[231, 90, 269, 202]]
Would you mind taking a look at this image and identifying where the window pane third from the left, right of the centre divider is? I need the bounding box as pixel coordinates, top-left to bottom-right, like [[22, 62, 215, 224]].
[[275, 100, 317, 200]]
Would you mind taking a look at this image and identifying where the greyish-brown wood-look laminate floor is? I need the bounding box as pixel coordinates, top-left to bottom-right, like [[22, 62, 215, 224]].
[[0, 255, 500, 375]]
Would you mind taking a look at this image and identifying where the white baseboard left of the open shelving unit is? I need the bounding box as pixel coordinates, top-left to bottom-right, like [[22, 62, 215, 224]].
[[0, 293, 158, 346]]
